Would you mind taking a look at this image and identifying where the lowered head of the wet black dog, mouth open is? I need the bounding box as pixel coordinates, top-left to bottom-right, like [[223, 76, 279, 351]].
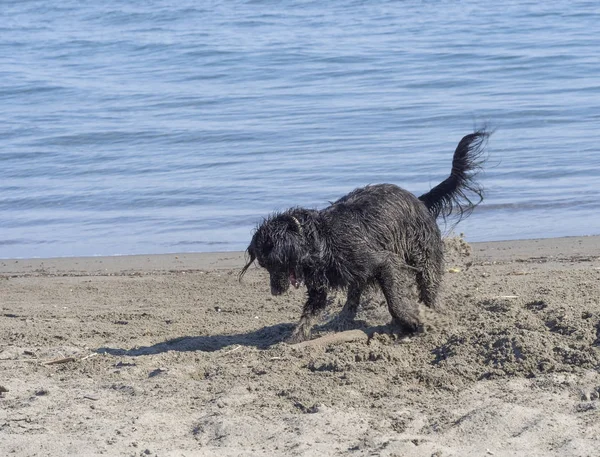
[[240, 213, 309, 295]]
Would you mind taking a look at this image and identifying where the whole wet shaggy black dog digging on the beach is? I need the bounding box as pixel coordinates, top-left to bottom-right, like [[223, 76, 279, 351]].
[[240, 130, 489, 342]]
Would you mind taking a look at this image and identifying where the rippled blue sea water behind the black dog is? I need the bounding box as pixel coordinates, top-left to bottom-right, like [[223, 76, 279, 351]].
[[0, 0, 600, 258]]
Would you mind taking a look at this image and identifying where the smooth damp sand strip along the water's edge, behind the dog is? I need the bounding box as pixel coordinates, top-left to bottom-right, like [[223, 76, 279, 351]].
[[0, 235, 600, 276]]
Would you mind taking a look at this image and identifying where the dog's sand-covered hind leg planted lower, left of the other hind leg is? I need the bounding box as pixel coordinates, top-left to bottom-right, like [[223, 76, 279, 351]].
[[376, 255, 421, 333]]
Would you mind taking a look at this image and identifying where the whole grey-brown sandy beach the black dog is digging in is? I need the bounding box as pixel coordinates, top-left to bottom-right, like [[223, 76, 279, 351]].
[[0, 237, 600, 457]]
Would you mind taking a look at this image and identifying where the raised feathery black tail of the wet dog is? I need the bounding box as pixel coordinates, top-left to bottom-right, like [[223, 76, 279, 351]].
[[419, 128, 491, 223]]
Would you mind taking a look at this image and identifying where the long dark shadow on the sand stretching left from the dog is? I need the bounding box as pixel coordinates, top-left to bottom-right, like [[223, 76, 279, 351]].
[[96, 323, 294, 357]]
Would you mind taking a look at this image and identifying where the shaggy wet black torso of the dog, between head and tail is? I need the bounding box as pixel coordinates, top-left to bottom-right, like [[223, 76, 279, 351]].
[[312, 184, 443, 292]]
